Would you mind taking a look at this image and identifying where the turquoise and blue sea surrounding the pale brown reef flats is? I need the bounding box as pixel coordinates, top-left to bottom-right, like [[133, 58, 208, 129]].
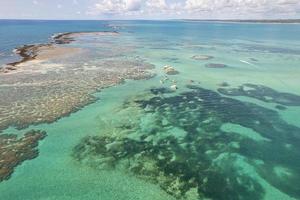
[[0, 20, 300, 200]]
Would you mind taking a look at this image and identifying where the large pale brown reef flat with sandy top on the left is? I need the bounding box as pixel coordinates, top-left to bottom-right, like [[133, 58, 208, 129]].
[[0, 32, 154, 132]]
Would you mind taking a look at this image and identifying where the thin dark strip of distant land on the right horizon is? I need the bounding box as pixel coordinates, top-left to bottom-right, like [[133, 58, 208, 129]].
[[183, 19, 300, 24]]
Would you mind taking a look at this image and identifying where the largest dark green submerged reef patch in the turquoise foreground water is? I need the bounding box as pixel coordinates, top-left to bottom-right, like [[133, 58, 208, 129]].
[[73, 85, 300, 200]]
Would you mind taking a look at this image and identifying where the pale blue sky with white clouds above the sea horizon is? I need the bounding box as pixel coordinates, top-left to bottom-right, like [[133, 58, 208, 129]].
[[0, 0, 300, 19]]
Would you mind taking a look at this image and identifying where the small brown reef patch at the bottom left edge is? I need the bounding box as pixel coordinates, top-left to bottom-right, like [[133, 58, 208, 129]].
[[0, 130, 46, 182]]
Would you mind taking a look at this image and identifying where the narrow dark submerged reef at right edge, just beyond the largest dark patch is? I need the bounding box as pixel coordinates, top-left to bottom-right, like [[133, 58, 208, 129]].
[[218, 83, 300, 106]]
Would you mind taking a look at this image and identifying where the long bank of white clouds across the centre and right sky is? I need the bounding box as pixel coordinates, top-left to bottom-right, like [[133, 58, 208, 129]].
[[88, 0, 300, 18]]
